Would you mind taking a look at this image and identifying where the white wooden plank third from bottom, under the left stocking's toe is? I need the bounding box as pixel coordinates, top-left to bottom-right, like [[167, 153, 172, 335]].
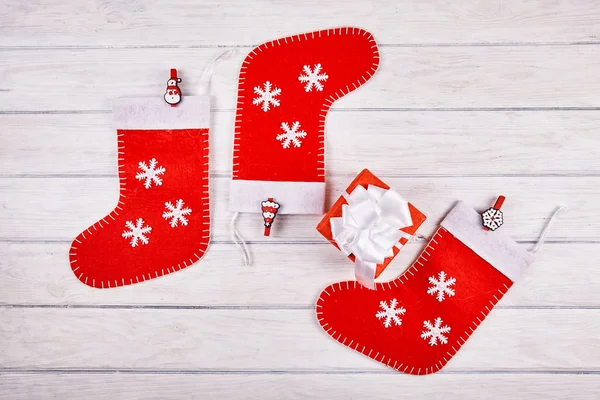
[[0, 243, 600, 308]]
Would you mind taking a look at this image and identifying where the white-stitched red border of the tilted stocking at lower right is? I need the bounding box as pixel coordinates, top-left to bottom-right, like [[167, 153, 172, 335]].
[[316, 226, 510, 375]]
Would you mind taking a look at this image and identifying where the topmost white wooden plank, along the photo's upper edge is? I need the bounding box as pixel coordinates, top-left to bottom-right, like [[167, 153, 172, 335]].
[[0, 0, 600, 47]]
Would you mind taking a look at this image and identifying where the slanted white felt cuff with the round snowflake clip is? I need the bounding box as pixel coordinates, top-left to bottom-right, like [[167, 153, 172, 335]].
[[441, 201, 534, 282]]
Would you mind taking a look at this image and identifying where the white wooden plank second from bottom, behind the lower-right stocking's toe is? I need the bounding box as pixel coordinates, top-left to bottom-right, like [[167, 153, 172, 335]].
[[0, 308, 600, 371]]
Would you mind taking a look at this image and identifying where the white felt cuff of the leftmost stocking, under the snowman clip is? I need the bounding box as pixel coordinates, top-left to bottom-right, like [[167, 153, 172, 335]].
[[113, 95, 210, 129]]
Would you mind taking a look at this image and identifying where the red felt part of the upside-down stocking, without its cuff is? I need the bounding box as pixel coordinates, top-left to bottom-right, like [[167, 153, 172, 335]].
[[233, 27, 379, 183]]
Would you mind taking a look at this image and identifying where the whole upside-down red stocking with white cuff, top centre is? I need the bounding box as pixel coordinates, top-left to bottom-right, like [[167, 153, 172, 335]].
[[229, 27, 379, 222]]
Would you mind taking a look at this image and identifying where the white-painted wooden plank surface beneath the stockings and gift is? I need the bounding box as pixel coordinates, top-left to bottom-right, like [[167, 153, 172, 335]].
[[0, 0, 600, 400]]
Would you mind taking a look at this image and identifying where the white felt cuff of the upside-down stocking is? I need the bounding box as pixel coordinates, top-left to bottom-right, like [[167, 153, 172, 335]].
[[229, 179, 325, 214]]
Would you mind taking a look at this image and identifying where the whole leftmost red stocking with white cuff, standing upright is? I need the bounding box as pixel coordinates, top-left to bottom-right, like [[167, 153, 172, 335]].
[[69, 96, 210, 288]]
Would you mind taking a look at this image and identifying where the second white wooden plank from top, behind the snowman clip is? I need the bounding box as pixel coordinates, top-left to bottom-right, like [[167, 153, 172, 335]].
[[0, 46, 600, 112]]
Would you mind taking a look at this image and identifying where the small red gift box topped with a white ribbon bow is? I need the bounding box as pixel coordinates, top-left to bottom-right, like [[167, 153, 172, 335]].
[[317, 169, 426, 287]]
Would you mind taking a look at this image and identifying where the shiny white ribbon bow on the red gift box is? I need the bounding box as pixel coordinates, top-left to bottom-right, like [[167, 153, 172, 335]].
[[330, 185, 413, 289]]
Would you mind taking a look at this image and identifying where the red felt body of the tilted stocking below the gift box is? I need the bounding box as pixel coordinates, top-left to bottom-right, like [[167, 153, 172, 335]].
[[316, 227, 512, 375]]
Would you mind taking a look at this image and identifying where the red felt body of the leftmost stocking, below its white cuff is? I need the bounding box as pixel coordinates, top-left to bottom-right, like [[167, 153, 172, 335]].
[[69, 129, 210, 288]]
